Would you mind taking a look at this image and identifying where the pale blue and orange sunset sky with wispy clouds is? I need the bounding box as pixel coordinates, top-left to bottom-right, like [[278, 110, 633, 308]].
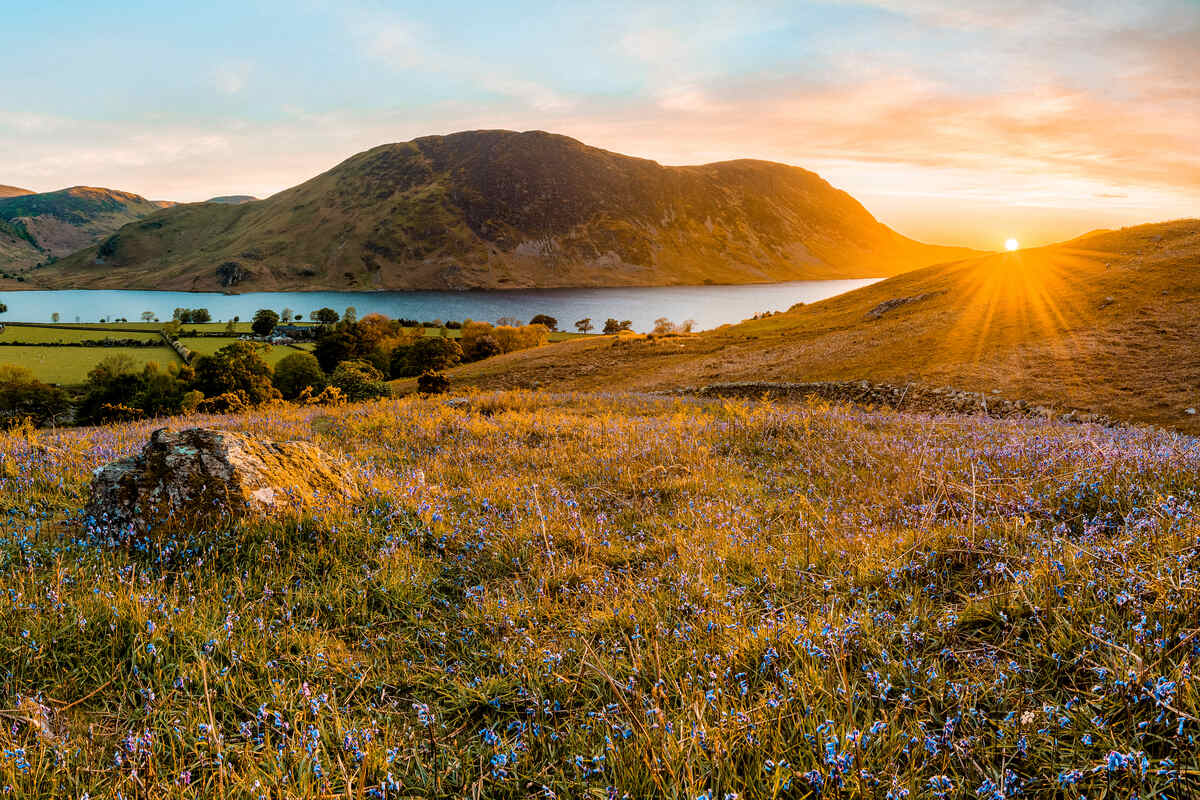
[[0, 0, 1200, 249]]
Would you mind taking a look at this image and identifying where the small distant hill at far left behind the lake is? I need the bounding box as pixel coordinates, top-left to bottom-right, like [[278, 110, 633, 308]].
[[0, 186, 169, 271]]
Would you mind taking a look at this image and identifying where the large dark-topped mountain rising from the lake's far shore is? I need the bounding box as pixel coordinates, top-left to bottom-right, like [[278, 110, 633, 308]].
[[41, 131, 970, 290]]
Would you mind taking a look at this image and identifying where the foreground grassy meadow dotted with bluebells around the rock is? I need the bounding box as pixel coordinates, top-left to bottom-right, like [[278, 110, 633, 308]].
[[0, 392, 1200, 800]]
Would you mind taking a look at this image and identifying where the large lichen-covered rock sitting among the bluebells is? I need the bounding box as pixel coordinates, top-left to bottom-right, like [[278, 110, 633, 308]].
[[85, 428, 356, 536]]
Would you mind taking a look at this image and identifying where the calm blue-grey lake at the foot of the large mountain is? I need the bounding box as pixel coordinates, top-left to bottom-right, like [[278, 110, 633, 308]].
[[0, 278, 875, 331]]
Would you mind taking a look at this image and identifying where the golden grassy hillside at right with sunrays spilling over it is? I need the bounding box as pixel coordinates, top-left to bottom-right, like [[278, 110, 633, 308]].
[[454, 219, 1200, 433]]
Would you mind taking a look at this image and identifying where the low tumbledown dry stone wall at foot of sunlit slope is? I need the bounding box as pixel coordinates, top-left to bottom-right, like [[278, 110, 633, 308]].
[[690, 380, 1115, 426]]
